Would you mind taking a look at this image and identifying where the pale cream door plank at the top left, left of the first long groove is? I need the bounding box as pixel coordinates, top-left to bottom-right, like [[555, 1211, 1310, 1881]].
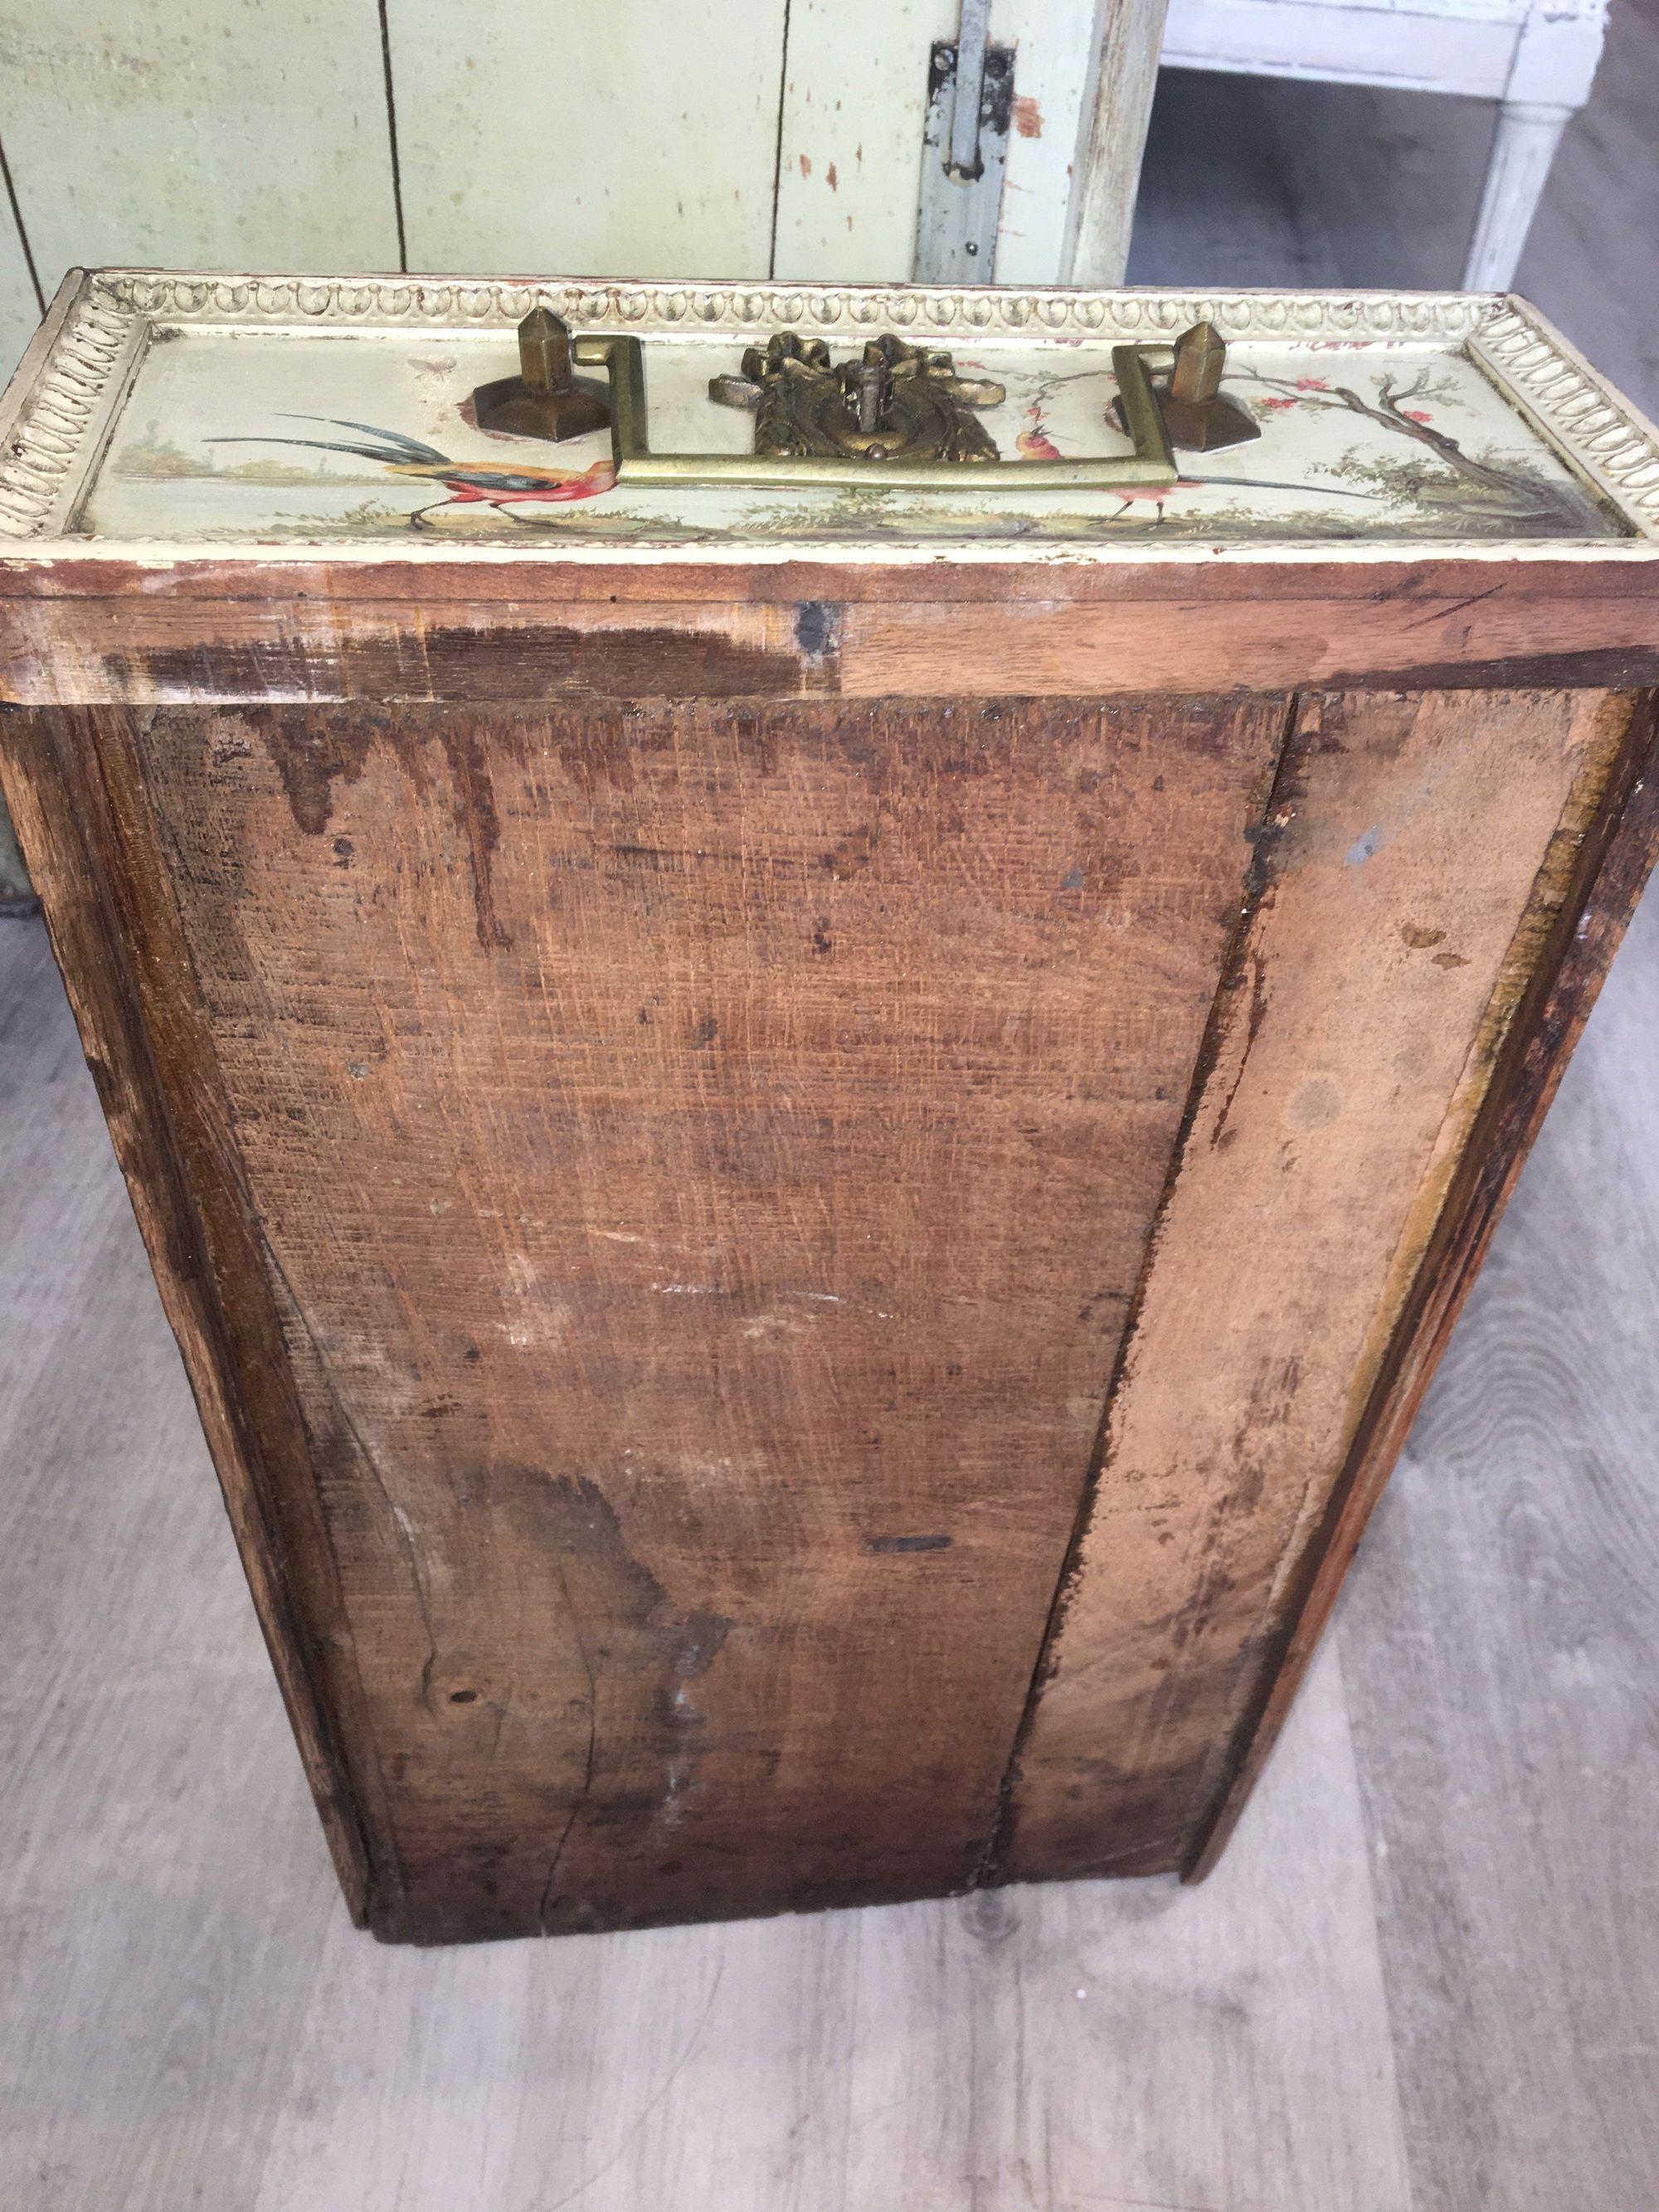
[[0, 0, 398, 307]]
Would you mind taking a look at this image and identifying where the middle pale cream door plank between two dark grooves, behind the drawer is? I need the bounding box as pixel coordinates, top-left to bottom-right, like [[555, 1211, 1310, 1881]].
[[387, 0, 786, 276]]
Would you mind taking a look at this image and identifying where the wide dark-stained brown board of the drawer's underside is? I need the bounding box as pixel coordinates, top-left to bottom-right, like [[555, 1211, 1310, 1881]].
[[129, 699, 1287, 1940]]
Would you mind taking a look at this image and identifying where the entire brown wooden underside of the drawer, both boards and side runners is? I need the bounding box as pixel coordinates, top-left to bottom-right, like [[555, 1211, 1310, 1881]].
[[7, 659, 1650, 1940]]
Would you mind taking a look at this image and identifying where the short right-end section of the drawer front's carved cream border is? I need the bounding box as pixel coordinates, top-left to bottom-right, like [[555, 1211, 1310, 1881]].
[[1471, 299, 1659, 537]]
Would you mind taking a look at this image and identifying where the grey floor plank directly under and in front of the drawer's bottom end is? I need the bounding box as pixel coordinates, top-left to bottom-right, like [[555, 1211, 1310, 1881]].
[[259, 1627, 1409, 2212]]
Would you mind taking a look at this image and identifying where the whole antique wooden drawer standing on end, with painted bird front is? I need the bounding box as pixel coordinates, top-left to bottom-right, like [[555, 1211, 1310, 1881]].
[[0, 270, 1659, 1942]]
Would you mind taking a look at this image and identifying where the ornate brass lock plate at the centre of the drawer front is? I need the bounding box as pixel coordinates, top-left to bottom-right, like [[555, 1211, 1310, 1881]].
[[708, 329, 1006, 462]]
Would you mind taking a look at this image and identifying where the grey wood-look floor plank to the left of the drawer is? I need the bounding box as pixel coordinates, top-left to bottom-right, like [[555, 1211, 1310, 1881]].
[[0, 920, 338, 2212]]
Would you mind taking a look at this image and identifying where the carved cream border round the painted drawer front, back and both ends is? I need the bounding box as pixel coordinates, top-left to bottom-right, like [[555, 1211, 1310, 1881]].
[[0, 270, 1659, 551]]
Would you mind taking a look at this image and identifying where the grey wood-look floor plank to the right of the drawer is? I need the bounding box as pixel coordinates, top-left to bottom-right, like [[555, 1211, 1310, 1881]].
[[1343, 876, 1659, 2212]]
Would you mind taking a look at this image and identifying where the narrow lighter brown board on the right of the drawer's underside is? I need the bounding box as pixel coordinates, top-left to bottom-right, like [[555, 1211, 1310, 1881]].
[[998, 693, 1630, 1878]]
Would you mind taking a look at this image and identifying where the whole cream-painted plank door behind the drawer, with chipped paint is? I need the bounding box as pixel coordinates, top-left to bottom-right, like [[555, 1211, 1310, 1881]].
[[0, 0, 1144, 374]]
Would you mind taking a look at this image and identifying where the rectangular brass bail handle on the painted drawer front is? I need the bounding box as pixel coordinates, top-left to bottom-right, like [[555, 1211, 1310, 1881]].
[[571, 336, 1179, 498]]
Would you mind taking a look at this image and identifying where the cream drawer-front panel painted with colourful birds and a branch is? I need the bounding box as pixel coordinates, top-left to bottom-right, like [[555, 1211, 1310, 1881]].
[[69, 323, 1622, 547]]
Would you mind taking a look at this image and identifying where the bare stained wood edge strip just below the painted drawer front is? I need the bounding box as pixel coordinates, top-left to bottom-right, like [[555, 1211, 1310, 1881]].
[[0, 560, 1659, 706]]
